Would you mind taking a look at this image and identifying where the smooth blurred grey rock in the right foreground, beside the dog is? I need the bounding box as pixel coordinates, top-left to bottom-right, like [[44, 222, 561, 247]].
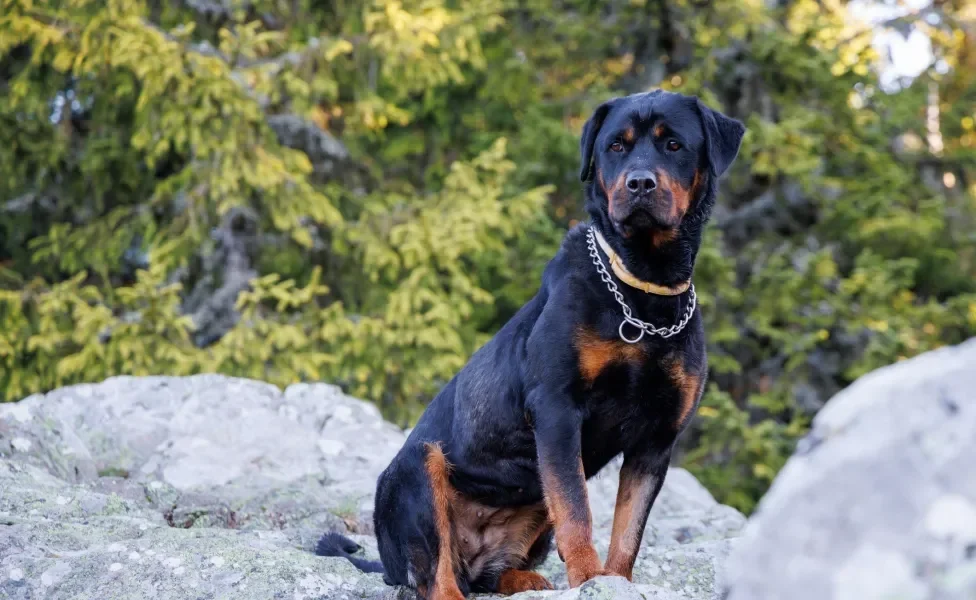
[[727, 340, 976, 600]]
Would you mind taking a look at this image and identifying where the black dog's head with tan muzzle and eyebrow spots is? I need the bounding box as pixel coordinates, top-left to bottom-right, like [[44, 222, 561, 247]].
[[580, 90, 745, 240]]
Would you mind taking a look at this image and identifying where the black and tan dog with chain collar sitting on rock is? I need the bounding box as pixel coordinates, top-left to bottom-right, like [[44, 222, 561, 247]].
[[318, 91, 745, 600]]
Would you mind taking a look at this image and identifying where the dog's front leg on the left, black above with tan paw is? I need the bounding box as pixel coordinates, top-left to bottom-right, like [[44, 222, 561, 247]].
[[534, 410, 605, 587]]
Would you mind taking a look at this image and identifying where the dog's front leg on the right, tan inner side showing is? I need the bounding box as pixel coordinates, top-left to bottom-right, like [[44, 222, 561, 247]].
[[606, 447, 671, 580]]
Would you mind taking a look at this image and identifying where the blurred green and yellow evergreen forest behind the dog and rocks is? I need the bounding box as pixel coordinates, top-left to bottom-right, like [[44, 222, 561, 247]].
[[0, 0, 976, 511]]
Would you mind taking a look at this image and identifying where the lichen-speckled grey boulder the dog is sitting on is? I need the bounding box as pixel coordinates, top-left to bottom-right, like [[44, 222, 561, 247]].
[[0, 376, 744, 600]]
